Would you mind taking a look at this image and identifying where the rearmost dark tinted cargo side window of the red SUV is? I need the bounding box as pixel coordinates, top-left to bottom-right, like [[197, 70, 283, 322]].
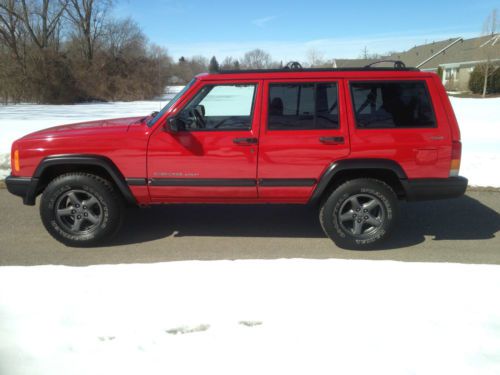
[[351, 81, 436, 129]]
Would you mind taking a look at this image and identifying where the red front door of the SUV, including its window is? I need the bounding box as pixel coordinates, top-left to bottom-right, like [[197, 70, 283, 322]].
[[148, 81, 261, 202]]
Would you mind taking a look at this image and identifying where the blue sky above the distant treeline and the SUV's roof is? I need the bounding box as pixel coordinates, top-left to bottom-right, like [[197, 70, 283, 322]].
[[115, 0, 500, 62]]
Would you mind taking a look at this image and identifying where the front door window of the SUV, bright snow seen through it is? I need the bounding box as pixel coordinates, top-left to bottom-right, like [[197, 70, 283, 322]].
[[178, 84, 256, 130]]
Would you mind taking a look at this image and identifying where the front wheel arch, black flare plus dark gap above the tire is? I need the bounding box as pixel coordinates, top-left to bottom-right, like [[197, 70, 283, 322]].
[[27, 155, 137, 205]]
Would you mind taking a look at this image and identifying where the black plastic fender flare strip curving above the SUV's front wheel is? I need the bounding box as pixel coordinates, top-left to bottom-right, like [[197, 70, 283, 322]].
[[31, 154, 137, 205]]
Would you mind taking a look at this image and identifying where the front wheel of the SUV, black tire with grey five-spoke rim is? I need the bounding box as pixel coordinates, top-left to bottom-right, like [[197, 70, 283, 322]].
[[40, 173, 123, 247]]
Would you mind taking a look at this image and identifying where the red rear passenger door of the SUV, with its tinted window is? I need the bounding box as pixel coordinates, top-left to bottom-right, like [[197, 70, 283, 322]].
[[258, 79, 349, 202]]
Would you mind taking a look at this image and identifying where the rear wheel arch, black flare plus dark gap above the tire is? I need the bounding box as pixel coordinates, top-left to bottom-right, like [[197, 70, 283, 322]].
[[310, 159, 407, 203]]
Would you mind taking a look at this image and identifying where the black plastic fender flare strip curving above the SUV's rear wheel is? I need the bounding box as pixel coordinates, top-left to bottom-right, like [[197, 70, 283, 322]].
[[310, 159, 408, 202]]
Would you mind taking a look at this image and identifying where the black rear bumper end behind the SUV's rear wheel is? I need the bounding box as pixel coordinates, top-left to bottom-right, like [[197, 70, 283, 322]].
[[403, 176, 468, 201]]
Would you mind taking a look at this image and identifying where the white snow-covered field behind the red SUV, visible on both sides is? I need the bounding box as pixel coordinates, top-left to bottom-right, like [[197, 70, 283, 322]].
[[0, 92, 500, 187]]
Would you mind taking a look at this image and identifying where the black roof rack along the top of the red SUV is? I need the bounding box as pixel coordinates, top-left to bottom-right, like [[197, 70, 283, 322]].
[[215, 60, 419, 74]]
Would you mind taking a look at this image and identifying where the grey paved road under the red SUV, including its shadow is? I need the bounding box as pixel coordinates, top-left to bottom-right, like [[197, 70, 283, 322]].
[[0, 189, 500, 268]]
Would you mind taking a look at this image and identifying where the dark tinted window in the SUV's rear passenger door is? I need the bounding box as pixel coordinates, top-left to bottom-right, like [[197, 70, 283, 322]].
[[268, 82, 339, 130]]
